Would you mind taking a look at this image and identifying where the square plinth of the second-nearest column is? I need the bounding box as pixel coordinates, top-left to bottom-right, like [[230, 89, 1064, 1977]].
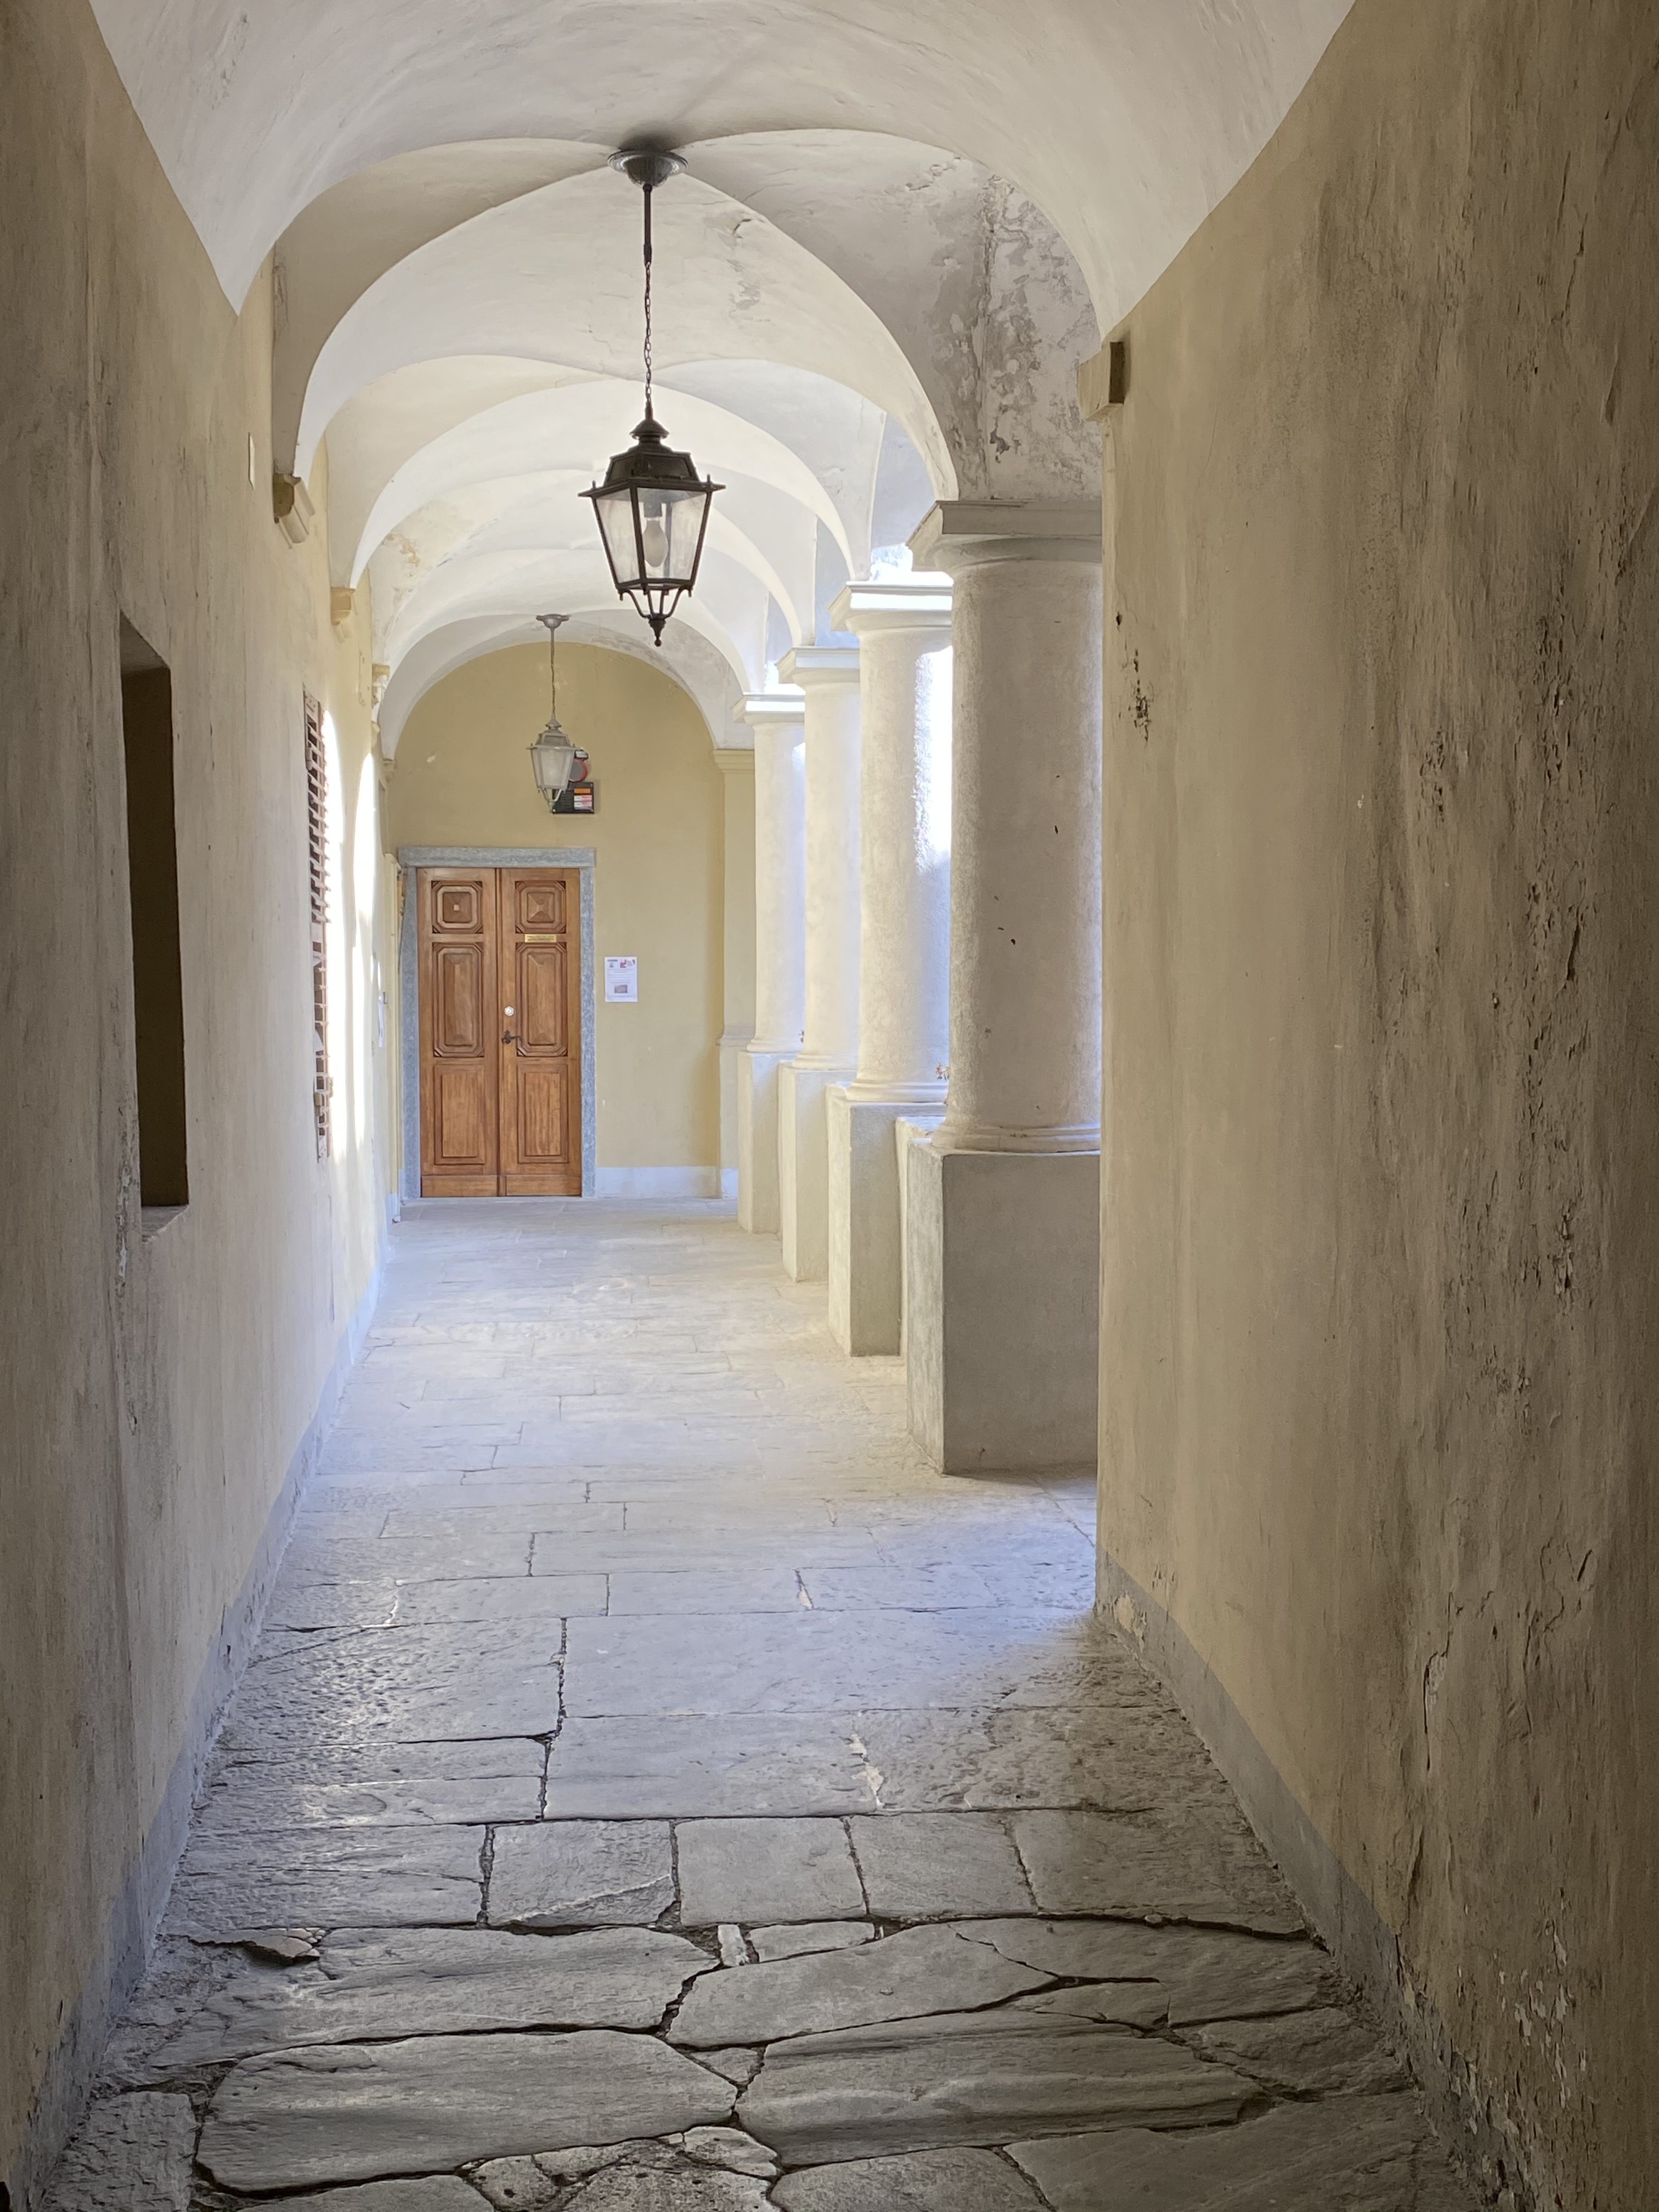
[[825, 1084, 942, 1356]]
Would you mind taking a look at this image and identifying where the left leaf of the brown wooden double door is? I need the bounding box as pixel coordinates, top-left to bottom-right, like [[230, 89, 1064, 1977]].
[[416, 867, 500, 1199]]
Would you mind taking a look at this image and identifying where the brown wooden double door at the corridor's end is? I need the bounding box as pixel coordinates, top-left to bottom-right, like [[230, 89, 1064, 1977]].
[[416, 867, 582, 1199]]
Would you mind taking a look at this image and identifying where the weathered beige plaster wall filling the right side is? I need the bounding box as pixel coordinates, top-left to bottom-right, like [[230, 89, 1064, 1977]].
[[1102, 0, 1659, 2212]]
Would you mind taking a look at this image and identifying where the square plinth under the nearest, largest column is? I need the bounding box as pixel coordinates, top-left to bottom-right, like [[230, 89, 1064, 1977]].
[[907, 1139, 1099, 1475]]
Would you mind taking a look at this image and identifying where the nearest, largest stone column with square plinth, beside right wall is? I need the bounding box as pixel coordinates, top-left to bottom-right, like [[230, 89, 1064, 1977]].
[[907, 500, 1102, 1473]]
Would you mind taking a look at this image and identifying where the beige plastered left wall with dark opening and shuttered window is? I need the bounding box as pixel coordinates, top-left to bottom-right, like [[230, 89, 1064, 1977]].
[[0, 0, 392, 2205]]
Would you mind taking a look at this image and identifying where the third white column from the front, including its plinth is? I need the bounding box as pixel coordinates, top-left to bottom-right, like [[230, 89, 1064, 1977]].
[[778, 646, 858, 1283]]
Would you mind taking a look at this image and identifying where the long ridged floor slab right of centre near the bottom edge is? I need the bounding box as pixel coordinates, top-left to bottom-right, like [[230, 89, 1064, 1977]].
[[739, 2008, 1256, 2165]]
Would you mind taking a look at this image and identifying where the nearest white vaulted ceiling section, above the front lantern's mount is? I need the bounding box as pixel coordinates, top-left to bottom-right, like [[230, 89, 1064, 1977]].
[[93, 0, 1347, 325]]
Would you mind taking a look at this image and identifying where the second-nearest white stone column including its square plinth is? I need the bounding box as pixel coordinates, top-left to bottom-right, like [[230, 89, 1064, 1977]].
[[825, 575, 951, 1352]]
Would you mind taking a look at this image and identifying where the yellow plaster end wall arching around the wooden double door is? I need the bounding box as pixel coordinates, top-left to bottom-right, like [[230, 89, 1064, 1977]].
[[387, 644, 723, 1172]]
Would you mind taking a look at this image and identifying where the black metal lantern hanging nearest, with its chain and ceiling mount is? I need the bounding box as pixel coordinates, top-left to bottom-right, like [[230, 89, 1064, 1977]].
[[582, 148, 725, 644]]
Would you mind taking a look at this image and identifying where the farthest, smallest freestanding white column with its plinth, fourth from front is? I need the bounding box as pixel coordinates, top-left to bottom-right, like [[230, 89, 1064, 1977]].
[[737, 690, 805, 1234]]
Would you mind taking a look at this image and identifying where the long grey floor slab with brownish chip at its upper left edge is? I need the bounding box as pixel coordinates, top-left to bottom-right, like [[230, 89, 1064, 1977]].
[[133, 1929, 710, 2077]]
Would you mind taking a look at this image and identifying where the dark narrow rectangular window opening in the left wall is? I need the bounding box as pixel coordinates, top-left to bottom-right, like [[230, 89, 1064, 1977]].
[[122, 617, 190, 1205]]
